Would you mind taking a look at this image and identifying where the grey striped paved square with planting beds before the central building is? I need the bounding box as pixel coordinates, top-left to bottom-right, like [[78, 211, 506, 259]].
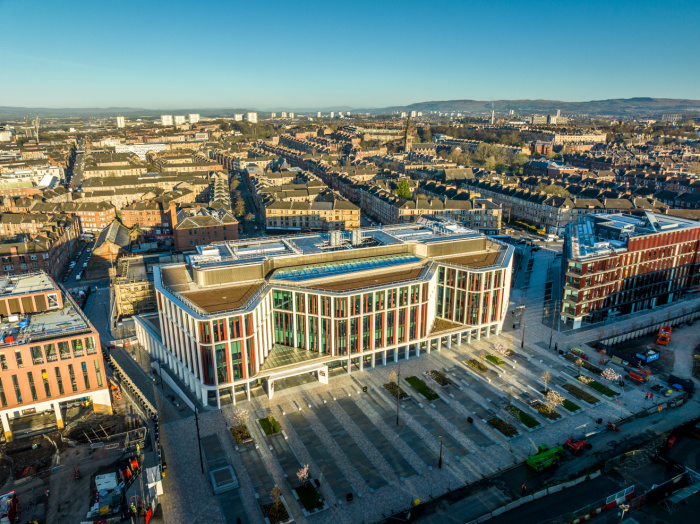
[[156, 247, 700, 523]]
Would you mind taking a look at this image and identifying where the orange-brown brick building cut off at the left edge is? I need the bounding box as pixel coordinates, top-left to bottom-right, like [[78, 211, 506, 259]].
[[0, 273, 112, 440]]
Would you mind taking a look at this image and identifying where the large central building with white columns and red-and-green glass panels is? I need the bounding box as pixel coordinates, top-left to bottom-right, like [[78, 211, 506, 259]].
[[135, 218, 513, 406]]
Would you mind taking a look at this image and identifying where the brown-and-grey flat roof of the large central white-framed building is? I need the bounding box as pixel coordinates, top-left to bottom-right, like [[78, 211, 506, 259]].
[[154, 217, 513, 316]]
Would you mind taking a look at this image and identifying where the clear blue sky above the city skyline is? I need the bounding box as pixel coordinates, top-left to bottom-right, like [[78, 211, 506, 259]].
[[0, 0, 700, 111]]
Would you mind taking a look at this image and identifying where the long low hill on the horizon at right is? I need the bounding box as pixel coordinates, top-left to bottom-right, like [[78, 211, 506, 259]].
[[375, 98, 700, 116]]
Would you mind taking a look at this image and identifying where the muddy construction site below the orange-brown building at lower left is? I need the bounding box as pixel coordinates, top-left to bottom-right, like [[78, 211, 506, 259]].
[[0, 352, 161, 524]]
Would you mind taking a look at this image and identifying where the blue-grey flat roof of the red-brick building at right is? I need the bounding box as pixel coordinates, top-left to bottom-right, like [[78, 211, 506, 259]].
[[567, 213, 700, 260]]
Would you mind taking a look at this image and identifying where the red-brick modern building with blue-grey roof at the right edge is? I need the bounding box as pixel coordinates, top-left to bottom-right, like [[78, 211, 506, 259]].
[[561, 213, 700, 328]]
